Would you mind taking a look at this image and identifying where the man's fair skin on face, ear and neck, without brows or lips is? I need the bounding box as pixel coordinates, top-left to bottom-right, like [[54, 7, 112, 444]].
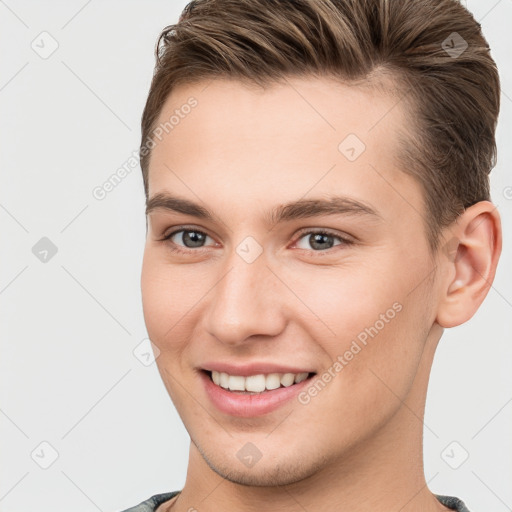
[[141, 78, 501, 512]]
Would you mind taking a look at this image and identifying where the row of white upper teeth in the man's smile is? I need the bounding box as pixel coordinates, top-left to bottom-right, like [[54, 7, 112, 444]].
[[212, 370, 308, 393]]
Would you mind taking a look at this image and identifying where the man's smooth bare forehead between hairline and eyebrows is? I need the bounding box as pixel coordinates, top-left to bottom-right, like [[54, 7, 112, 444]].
[[145, 78, 421, 222]]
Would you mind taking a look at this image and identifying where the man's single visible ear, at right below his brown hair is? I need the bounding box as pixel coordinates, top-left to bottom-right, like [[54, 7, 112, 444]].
[[436, 201, 502, 327]]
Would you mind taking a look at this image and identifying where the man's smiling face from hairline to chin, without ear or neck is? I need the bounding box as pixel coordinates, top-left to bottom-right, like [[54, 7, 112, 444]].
[[141, 79, 438, 485]]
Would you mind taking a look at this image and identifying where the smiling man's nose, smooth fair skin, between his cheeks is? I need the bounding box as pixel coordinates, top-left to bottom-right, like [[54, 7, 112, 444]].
[[203, 247, 286, 345]]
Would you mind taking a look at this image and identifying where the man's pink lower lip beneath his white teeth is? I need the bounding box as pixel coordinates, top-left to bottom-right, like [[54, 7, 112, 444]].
[[200, 371, 312, 418]]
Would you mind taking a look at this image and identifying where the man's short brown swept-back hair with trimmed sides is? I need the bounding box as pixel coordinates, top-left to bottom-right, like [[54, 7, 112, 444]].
[[140, 0, 500, 249]]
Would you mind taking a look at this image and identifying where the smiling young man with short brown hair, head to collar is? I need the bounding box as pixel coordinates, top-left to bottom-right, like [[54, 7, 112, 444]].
[[123, 0, 501, 512]]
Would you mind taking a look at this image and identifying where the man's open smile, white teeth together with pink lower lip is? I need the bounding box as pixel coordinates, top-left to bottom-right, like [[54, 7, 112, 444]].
[[199, 369, 316, 418]]
